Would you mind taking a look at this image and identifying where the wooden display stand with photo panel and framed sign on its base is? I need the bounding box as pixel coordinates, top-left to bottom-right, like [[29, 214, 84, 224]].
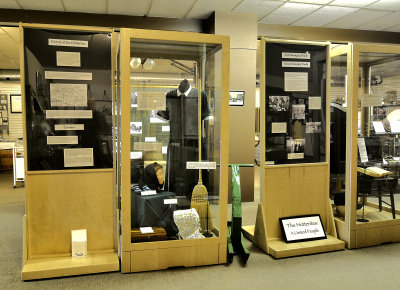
[[243, 39, 344, 258]]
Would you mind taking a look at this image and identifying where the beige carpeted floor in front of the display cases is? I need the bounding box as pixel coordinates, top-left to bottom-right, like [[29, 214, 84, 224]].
[[0, 173, 400, 289]]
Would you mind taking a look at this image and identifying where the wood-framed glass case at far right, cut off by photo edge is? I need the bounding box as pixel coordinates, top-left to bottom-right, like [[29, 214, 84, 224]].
[[330, 43, 400, 248]]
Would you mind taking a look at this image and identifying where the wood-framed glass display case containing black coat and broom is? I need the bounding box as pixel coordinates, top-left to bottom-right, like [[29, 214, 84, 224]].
[[121, 29, 229, 272]]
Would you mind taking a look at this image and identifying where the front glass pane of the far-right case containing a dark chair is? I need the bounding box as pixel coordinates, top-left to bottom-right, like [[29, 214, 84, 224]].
[[357, 53, 400, 223]]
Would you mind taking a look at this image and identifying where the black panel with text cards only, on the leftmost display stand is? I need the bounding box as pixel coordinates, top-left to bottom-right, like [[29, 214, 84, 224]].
[[24, 28, 113, 170]]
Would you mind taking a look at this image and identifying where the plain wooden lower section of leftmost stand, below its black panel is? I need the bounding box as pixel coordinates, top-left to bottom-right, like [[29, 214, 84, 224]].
[[22, 169, 119, 280]]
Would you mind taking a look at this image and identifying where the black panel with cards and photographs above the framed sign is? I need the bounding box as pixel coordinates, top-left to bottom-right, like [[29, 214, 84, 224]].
[[265, 42, 327, 164]]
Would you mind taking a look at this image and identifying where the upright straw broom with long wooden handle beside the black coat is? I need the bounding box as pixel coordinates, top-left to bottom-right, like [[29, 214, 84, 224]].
[[190, 79, 212, 236]]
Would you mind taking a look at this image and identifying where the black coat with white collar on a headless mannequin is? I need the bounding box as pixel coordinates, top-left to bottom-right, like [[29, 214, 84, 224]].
[[158, 80, 209, 197]]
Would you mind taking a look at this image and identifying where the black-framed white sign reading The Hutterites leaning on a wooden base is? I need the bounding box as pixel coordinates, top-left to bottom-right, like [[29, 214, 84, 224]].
[[279, 214, 326, 243]]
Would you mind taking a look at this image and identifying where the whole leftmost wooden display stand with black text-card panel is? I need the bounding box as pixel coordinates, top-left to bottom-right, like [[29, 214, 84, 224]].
[[20, 24, 119, 280]]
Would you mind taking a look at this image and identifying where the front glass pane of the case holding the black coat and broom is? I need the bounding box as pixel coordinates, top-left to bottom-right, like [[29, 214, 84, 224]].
[[130, 39, 222, 242]]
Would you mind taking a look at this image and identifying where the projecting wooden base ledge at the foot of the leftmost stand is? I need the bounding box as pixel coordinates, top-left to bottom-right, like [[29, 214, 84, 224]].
[[22, 253, 119, 280]]
